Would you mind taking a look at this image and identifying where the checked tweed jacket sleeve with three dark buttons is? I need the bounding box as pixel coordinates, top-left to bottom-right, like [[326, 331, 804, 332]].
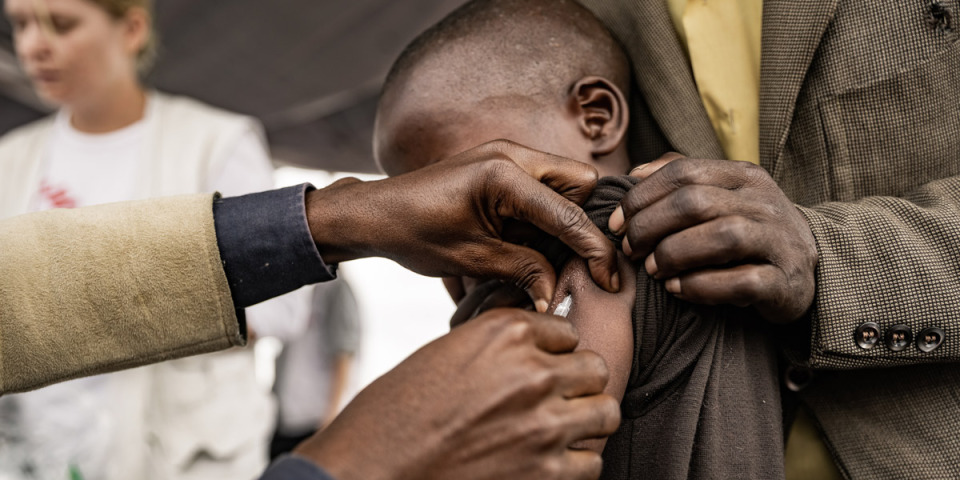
[[801, 177, 960, 369]]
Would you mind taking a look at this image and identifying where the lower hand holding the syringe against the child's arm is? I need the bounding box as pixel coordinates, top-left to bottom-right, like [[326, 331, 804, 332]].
[[296, 309, 620, 480]]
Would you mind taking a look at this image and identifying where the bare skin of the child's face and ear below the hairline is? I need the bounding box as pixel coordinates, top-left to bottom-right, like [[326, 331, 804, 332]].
[[374, 69, 630, 301]]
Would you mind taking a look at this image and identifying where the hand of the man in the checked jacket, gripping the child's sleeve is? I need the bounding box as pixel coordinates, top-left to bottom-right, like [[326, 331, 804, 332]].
[[609, 153, 817, 323]]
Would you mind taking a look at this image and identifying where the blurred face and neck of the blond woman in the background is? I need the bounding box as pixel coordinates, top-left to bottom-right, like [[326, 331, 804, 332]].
[[4, 0, 150, 133]]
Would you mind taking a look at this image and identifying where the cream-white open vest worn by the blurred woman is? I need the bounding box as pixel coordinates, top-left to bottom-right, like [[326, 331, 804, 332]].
[[0, 92, 275, 480]]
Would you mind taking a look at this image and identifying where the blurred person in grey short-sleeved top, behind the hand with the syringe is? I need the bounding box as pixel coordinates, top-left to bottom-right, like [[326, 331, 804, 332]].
[[270, 278, 361, 460]]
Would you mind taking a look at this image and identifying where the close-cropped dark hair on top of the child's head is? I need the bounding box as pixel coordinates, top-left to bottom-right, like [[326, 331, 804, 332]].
[[384, 0, 630, 102]]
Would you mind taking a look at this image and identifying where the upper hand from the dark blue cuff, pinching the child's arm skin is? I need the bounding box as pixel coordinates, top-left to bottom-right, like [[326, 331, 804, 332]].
[[307, 140, 619, 312]]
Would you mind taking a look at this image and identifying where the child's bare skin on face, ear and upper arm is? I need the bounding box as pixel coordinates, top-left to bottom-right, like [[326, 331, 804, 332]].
[[374, 52, 635, 453]]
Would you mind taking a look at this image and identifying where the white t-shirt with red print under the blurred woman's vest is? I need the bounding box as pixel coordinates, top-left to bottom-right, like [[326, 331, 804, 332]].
[[0, 97, 283, 479]]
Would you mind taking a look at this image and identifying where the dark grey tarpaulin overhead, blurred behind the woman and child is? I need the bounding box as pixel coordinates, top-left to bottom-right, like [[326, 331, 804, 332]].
[[0, 0, 464, 172]]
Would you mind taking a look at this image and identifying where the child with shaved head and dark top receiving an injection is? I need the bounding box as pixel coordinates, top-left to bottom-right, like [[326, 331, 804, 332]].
[[374, 0, 783, 478]]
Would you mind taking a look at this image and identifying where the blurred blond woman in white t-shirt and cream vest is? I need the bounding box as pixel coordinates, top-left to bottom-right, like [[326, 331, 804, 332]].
[[0, 0, 289, 480]]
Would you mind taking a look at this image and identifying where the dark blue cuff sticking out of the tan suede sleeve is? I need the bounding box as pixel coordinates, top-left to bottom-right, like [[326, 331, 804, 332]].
[[213, 183, 337, 310]]
